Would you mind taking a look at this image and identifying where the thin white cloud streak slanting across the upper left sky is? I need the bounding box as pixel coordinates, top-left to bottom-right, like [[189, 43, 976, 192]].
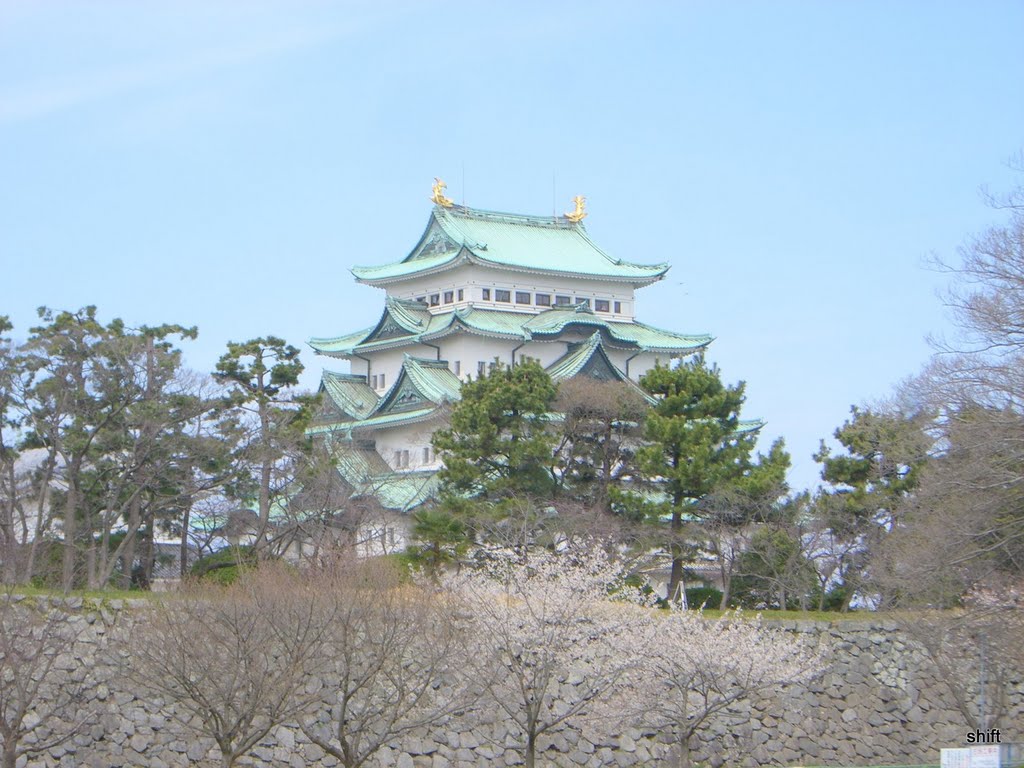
[[0, 22, 350, 124]]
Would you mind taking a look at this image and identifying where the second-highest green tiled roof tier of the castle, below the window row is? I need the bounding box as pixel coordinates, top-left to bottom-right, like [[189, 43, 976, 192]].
[[309, 301, 712, 357]]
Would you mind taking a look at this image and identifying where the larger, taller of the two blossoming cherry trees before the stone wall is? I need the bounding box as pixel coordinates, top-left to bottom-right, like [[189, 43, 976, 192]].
[[443, 542, 649, 768]]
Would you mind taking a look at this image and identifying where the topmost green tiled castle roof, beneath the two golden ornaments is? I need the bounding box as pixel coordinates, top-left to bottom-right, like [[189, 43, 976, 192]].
[[352, 206, 669, 285]]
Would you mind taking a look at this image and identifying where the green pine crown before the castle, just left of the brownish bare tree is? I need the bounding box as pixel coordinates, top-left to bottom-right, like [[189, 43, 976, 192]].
[[433, 360, 557, 498]]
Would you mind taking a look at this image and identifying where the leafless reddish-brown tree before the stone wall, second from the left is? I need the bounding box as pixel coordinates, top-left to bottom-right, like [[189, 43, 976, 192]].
[[130, 565, 329, 768]]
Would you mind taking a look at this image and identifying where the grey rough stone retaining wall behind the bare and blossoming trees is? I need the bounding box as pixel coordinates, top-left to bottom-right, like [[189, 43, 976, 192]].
[[6, 599, 1024, 768]]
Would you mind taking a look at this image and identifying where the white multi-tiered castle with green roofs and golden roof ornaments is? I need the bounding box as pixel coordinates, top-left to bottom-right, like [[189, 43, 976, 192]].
[[309, 179, 712, 512]]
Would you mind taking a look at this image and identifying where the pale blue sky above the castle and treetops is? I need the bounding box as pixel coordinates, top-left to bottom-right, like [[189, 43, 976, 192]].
[[0, 0, 1024, 487]]
